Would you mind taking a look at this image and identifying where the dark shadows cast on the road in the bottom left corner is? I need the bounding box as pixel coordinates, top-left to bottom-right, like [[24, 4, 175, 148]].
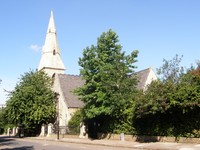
[[0, 136, 34, 150]]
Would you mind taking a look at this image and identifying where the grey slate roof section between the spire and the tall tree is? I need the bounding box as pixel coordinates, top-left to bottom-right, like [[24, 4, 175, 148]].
[[58, 74, 84, 108]]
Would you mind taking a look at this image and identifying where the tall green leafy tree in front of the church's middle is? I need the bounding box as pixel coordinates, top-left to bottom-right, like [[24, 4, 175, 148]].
[[77, 30, 138, 132]]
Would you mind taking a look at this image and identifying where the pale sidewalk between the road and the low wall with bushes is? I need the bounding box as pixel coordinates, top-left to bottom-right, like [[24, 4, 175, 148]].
[[29, 137, 200, 150]]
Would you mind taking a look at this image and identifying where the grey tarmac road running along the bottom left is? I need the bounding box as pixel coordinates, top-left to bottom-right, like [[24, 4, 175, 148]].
[[0, 137, 133, 150]]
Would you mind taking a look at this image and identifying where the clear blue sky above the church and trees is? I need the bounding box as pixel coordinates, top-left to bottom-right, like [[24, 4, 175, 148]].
[[0, 0, 200, 104]]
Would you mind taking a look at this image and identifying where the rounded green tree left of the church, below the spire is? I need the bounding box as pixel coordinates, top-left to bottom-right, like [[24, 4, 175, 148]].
[[6, 71, 56, 134]]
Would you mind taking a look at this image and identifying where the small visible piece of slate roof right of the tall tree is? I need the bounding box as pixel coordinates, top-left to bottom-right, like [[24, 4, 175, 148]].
[[135, 68, 151, 90]]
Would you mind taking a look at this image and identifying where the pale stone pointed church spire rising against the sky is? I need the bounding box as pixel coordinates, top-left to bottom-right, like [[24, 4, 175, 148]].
[[38, 11, 65, 76]]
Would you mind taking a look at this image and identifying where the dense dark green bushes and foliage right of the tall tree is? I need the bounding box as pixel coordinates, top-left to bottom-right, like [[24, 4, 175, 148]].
[[134, 55, 200, 137]]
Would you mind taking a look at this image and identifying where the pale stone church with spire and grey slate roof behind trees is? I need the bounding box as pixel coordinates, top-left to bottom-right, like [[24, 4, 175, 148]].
[[38, 12, 157, 126]]
